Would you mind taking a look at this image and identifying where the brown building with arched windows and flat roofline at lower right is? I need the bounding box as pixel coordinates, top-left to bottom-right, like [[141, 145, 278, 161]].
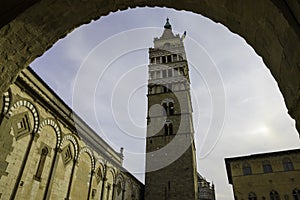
[[225, 149, 300, 200]]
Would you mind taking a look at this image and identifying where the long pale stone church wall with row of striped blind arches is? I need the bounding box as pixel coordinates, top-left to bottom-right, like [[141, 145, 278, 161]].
[[0, 68, 144, 200]]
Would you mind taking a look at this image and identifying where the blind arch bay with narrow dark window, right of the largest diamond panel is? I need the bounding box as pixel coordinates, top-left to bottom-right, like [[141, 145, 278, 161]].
[[16, 118, 61, 199]]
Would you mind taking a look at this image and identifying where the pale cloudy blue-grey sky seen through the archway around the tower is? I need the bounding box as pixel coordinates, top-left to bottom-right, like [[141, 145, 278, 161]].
[[30, 8, 299, 200]]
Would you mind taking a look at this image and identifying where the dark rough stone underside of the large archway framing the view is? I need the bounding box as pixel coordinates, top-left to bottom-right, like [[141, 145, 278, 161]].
[[0, 0, 300, 132]]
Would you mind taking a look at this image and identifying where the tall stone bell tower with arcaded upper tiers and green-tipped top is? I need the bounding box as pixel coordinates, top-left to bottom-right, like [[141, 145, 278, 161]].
[[145, 19, 198, 200]]
